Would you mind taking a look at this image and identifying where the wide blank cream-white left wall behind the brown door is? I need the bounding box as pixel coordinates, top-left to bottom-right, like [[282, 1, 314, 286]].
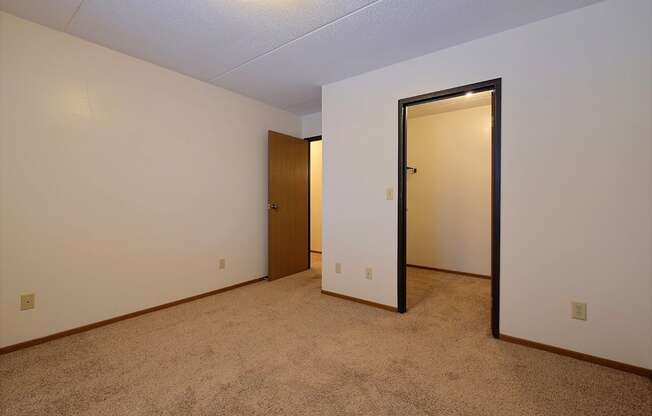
[[0, 13, 301, 346]]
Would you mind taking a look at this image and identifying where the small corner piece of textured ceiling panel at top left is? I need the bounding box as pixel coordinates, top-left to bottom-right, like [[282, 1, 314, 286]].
[[0, 0, 82, 30]]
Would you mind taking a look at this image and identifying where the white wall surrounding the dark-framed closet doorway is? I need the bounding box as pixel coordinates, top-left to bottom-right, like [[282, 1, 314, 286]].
[[322, 0, 652, 368]]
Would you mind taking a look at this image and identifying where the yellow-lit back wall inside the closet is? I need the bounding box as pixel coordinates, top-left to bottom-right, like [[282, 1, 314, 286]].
[[407, 106, 491, 276]]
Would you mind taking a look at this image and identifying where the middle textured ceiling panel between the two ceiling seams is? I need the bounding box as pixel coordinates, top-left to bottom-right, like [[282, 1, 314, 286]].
[[69, 0, 372, 80]]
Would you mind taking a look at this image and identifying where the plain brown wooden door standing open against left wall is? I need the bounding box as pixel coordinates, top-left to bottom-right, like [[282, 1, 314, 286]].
[[267, 131, 310, 280]]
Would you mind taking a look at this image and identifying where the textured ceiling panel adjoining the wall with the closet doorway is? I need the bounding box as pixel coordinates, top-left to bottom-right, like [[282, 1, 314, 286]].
[[213, 0, 597, 114]]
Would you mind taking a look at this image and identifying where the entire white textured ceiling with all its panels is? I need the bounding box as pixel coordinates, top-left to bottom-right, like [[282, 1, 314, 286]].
[[0, 0, 599, 115]]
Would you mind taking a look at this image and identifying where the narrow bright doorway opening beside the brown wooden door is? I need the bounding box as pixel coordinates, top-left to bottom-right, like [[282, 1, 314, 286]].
[[305, 136, 323, 273]]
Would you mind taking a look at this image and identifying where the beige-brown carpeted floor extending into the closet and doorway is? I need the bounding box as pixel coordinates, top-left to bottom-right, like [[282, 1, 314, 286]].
[[0, 254, 652, 416]]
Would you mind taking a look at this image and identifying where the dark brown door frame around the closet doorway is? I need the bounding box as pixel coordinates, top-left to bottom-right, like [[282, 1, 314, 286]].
[[397, 78, 501, 338]]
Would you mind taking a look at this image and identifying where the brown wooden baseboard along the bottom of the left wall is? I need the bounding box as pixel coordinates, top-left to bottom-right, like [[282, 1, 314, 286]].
[[0, 277, 266, 355]]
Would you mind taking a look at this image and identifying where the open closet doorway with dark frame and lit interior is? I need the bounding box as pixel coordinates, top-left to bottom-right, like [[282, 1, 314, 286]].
[[397, 79, 500, 338]]
